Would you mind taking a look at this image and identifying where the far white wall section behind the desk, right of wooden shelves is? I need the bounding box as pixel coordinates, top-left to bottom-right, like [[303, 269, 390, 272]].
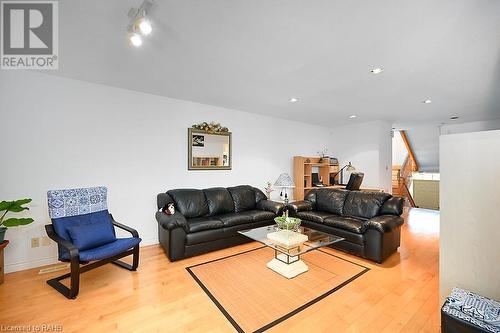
[[328, 121, 392, 193]]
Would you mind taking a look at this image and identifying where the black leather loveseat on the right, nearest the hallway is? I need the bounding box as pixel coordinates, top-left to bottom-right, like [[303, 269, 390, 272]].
[[292, 188, 404, 263]]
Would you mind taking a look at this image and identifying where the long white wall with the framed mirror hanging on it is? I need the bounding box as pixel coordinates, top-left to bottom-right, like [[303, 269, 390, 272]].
[[0, 71, 332, 271]]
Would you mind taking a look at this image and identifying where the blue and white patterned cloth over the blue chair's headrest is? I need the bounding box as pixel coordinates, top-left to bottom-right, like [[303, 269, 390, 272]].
[[47, 186, 108, 219]]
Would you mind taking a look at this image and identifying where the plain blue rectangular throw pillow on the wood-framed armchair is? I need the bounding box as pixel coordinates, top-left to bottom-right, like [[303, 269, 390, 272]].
[[68, 216, 116, 251]]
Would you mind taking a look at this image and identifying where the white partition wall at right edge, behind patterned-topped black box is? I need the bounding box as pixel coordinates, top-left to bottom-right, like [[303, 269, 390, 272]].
[[439, 131, 500, 300]]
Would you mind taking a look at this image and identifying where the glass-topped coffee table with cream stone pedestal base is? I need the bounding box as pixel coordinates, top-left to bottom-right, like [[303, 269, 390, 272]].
[[238, 225, 344, 279]]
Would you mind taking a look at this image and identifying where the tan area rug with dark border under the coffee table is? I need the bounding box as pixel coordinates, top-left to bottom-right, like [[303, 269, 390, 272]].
[[186, 247, 369, 332]]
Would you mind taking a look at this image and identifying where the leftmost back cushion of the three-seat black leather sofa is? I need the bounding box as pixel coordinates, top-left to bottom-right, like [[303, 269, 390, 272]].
[[167, 189, 209, 218]]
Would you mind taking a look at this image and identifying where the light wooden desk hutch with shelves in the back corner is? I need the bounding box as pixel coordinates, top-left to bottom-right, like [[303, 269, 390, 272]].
[[293, 156, 340, 200]]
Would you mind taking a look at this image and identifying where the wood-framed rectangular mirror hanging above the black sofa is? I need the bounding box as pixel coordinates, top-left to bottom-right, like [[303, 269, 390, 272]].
[[188, 128, 232, 170]]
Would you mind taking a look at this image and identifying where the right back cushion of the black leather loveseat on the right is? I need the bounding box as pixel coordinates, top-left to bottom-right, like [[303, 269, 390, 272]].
[[343, 191, 391, 219]]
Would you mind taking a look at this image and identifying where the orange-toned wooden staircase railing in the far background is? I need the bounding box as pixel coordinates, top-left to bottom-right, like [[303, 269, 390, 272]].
[[392, 131, 418, 207]]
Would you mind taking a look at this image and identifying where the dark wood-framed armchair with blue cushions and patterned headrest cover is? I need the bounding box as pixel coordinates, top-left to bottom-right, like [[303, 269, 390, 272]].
[[45, 187, 141, 299]]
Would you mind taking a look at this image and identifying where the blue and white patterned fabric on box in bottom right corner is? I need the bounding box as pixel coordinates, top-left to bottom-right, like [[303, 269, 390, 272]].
[[443, 288, 500, 333]]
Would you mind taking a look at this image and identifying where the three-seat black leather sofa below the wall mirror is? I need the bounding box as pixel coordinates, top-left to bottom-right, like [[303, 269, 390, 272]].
[[156, 185, 283, 261]]
